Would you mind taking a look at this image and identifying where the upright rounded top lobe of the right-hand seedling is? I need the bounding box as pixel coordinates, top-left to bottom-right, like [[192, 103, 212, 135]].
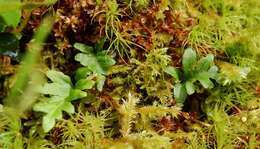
[[182, 48, 197, 76]]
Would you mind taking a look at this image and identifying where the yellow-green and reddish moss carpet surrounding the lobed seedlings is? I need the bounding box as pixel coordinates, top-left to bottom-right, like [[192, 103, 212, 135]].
[[0, 0, 260, 149]]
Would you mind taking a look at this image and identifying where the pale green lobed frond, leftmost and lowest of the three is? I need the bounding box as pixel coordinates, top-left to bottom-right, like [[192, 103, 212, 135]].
[[33, 70, 88, 132]]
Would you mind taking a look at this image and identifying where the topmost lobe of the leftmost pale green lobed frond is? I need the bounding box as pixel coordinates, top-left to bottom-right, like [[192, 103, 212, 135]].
[[46, 70, 71, 84]]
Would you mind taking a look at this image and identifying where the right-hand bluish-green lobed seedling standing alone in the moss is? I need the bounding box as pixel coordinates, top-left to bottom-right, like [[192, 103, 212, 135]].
[[164, 48, 218, 103]]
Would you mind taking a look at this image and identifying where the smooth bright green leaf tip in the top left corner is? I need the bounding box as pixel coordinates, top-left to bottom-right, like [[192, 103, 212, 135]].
[[0, 0, 22, 27]]
